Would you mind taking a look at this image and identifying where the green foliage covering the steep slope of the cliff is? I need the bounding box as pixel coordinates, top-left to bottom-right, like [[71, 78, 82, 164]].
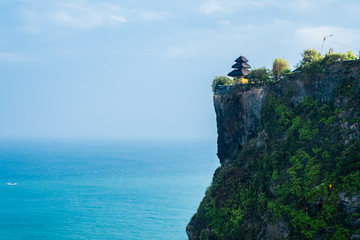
[[188, 59, 360, 240]]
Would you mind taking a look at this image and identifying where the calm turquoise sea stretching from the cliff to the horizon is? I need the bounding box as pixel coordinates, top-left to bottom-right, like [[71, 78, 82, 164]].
[[0, 141, 218, 240]]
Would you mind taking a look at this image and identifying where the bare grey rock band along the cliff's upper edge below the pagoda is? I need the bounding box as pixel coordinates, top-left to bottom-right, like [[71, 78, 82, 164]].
[[214, 61, 360, 163]]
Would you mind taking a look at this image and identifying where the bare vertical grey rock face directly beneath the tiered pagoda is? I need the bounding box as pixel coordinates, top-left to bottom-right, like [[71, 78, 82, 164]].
[[214, 86, 264, 163]]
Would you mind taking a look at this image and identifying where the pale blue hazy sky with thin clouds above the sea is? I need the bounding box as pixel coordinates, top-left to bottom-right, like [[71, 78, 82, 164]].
[[0, 0, 360, 140]]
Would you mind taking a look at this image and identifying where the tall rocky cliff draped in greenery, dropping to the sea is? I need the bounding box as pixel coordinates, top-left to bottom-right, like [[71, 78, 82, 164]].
[[187, 60, 360, 239]]
